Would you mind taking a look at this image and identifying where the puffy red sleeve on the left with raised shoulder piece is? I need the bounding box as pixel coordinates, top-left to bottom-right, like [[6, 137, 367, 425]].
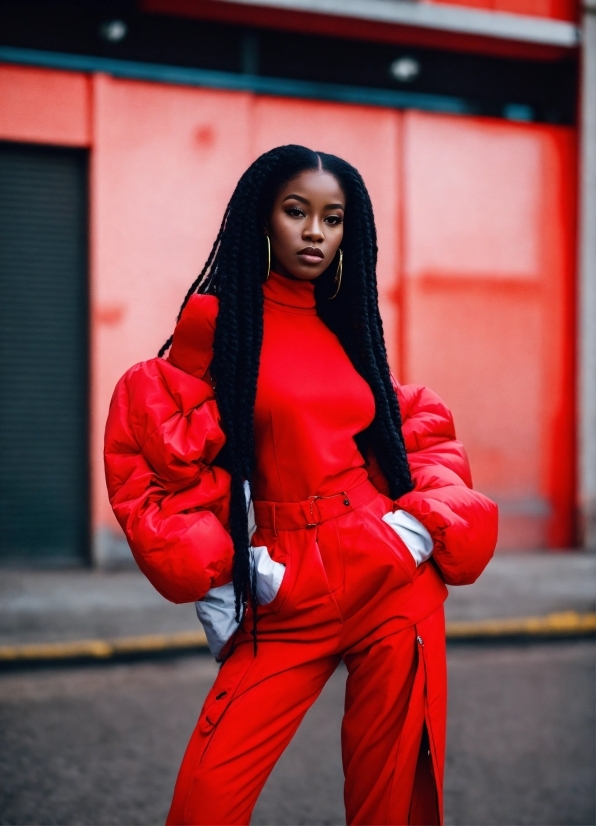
[[104, 296, 233, 603]]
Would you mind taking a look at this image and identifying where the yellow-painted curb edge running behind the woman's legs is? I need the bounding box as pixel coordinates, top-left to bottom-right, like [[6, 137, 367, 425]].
[[0, 611, 596, 668]]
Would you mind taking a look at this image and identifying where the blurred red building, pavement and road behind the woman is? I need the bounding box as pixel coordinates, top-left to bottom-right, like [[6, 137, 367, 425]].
[[0, 0, 596, 824]]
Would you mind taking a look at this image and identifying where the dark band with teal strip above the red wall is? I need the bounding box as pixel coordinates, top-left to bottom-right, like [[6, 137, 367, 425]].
[[0, 0, 577, 124]]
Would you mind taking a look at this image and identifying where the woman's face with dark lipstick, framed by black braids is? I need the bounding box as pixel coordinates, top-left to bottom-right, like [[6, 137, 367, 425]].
[[265, 170, 346, 281]]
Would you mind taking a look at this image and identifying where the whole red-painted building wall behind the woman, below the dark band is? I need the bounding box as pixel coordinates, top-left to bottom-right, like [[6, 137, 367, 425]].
[[0, 67, 575, 548]]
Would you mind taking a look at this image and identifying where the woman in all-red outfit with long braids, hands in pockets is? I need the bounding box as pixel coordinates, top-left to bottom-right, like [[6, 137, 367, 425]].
[[106, 146, 496, 824]]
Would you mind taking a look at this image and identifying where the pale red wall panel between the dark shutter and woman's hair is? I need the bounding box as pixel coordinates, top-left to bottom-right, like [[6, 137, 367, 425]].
[[92, 76, 250, 544]]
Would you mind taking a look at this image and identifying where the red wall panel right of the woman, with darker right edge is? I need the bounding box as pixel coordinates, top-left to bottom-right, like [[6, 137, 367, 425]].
[[404, 113, 574, 548]]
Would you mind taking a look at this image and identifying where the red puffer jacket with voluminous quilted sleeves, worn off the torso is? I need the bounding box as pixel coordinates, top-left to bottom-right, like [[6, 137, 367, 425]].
[[105, 296, 497, 603]]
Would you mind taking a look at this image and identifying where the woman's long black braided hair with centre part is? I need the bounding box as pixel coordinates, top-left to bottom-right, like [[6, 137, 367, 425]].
[[159, 144, 413, 645]]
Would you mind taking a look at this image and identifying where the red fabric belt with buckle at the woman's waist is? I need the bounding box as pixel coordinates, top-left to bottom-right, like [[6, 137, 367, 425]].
[[253, 480, 379, 533]]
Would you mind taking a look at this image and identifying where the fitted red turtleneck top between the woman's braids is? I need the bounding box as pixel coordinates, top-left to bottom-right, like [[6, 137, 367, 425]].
[[253, 272, 375, 502]]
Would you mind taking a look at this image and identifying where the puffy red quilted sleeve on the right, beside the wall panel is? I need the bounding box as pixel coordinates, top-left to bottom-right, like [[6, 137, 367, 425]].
[[388, 385, 498, 585]]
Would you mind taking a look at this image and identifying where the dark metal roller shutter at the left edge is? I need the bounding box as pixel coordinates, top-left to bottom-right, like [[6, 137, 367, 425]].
[[0, 143, 89, 565]]
